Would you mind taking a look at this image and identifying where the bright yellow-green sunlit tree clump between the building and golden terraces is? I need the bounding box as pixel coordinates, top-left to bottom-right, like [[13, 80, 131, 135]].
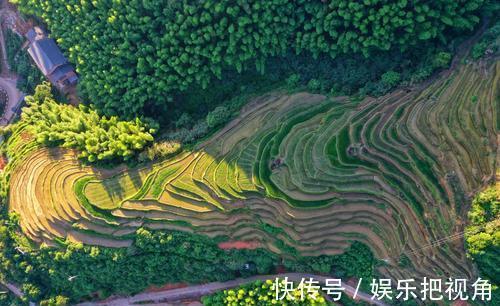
[[22, 83, 155, 162]]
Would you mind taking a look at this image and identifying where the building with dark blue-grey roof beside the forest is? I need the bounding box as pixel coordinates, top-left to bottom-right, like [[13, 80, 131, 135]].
[[26, 27, 78, 91]]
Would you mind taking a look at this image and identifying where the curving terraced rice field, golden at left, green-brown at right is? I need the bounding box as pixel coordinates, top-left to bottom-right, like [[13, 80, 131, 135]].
[[10, 62, 500, 278]]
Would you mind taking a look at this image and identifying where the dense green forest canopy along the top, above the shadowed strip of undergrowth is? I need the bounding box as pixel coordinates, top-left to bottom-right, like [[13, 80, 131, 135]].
[[13, 0, 487, 118]]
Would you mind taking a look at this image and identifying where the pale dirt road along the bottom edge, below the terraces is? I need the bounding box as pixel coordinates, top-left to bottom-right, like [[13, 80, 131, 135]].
[[79, 273, 387, 306]]
